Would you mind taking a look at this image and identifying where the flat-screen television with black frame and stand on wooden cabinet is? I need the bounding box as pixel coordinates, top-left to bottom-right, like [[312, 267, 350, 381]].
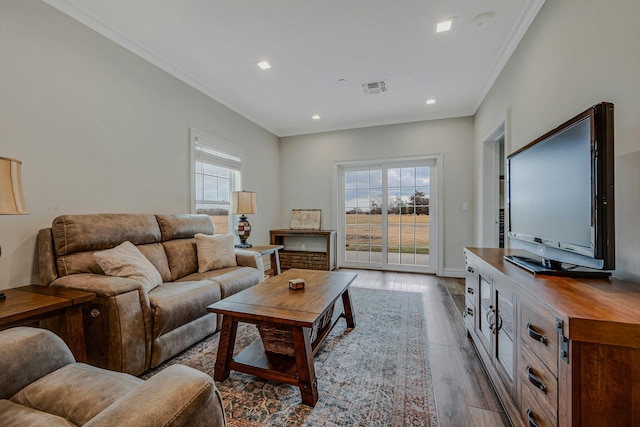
[[506, 102, 615, 276]]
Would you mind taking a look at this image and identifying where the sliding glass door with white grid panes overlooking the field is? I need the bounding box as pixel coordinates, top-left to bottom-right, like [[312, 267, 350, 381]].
[[339, 159, 436, 272]]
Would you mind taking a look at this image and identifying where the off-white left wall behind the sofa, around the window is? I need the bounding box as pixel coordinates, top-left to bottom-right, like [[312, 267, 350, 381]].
[[0, 0, 280, 289]]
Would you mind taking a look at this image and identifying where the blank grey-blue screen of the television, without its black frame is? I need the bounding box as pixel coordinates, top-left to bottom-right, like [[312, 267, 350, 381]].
[[509, 119, 593, 254]]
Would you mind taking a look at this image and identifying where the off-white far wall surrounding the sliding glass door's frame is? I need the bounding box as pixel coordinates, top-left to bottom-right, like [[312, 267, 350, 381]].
[[280, 117, 473, 274]]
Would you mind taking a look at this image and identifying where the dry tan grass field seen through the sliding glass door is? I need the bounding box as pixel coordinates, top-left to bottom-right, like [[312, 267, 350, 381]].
[[345, 213, 429, 254]]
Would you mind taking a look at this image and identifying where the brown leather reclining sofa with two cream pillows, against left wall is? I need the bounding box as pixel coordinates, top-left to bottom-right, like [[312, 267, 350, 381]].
[[38, 214, 264, 375]]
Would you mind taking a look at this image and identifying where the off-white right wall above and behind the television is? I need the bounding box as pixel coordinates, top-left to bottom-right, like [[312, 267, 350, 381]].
[[475, 0, 640, 281]]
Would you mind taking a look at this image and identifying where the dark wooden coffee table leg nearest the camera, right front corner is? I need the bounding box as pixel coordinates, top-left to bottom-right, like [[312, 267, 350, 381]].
[[291, 326, 318, 406]]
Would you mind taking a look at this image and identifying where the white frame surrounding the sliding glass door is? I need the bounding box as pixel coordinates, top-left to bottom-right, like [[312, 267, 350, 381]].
[[332, 153, 444, 276]]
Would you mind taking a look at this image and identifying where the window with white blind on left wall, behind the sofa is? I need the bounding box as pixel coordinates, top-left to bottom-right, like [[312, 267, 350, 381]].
[[191, 129, 242, 234]]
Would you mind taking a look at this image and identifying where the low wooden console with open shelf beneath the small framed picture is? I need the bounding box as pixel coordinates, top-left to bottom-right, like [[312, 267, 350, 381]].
[[270, 230, 337, 271]]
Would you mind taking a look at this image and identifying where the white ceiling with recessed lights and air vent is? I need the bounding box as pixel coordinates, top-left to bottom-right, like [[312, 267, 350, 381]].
[[43, 0, 544, 136]]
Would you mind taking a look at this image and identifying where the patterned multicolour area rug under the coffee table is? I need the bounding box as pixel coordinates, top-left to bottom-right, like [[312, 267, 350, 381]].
[[144, 287, 438, 427]]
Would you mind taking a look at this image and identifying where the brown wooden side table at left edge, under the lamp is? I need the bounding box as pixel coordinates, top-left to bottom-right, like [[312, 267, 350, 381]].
[[0, 285, 96, 362]]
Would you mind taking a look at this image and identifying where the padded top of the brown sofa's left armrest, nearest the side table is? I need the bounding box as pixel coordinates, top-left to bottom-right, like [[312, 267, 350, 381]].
[[50, 273, 144, 298]]
